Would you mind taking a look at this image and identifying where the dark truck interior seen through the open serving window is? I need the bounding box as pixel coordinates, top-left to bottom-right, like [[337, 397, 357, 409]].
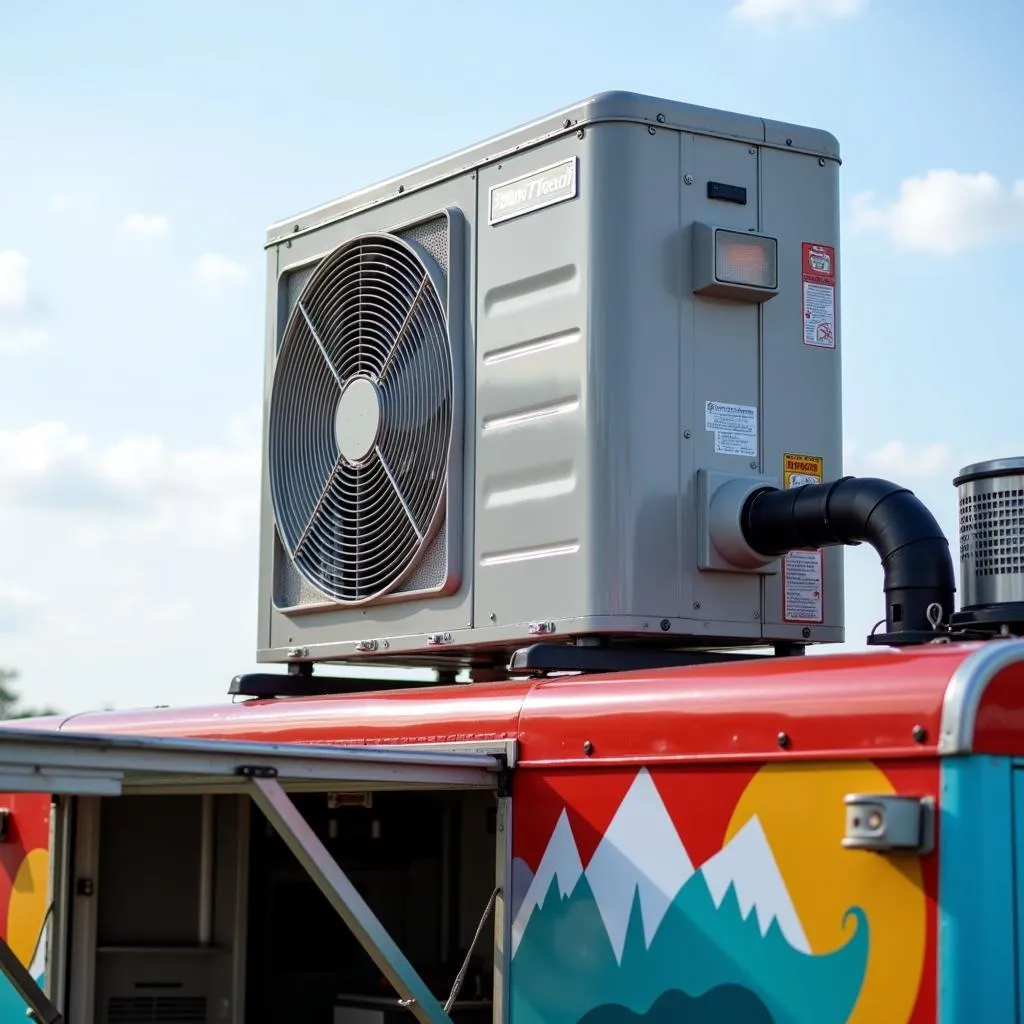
[[72, 791, 497, 1024]]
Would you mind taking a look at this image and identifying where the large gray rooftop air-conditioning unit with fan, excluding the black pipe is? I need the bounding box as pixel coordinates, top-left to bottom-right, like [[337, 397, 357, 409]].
[[258, 92, 844, 666]]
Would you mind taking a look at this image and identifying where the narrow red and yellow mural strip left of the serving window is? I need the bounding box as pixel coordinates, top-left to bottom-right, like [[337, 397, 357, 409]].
[[0, 795, 50, 1024]]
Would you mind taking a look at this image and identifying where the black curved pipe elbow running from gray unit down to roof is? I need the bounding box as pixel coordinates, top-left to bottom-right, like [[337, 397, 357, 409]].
[[741, 476, 956, 634]]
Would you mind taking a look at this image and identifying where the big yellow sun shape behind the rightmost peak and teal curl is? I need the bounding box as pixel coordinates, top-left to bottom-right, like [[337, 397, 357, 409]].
[[725, 763, 926, 1024]]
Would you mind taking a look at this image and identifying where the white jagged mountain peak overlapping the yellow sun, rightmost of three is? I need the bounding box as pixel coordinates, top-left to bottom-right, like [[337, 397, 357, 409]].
[[700, 814, 811, 953]]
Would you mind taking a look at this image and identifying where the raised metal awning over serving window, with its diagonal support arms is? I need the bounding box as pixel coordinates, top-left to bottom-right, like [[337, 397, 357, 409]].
[[0, 728, 508, 1024]]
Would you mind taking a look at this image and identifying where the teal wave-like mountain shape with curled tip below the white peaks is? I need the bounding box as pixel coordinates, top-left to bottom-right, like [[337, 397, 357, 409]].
[[510, 871, 869, 1024]]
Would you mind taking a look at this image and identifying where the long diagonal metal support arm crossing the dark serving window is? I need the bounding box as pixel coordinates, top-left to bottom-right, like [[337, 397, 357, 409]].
[[247, 778, 452, 1024]]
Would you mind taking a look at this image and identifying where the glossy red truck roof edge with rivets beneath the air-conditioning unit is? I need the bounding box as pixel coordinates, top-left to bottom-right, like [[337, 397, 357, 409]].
[[14, 640, 1024, 766]]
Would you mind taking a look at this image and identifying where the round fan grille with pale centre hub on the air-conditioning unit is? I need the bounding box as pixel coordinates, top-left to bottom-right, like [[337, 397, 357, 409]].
[[268, 234, 454, 604]]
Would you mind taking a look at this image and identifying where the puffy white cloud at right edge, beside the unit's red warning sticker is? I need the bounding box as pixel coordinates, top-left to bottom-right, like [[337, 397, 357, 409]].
[[851, 170, 1024, 255]]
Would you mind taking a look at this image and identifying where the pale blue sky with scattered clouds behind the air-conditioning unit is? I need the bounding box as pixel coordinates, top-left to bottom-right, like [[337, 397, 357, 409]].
[[0, 0, 1024, 710]]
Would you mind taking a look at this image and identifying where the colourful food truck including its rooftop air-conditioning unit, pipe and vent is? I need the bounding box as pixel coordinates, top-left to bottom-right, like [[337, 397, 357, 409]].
[[0, 93, 1024, 1024]]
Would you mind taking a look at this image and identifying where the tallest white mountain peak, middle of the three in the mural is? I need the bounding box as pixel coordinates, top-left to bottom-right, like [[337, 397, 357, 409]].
[[587, 769, 693, 961]]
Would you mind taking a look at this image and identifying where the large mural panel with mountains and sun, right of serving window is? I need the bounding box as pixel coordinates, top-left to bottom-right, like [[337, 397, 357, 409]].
[[511, 764, 934, 1024]]
